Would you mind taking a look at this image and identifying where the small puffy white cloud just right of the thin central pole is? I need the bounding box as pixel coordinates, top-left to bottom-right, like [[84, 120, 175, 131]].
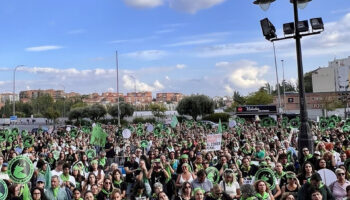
[[122, 75, 164, 92]]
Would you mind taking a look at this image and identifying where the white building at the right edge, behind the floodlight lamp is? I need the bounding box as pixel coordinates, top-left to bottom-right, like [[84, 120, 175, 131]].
[[312, 56, 350, 92]]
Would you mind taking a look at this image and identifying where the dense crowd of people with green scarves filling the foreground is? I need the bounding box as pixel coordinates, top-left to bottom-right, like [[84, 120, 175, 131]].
[[0, 117, 350, 200]]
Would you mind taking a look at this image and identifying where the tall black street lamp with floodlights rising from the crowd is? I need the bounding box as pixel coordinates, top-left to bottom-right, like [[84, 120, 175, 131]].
[[254, 0, 323, 158]]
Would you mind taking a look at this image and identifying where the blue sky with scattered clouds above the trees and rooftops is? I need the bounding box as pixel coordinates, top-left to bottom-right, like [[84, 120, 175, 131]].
[[0, 0, 350, 97]]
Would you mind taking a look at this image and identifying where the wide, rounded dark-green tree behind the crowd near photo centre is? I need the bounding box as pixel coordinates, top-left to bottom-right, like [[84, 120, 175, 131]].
[[176, 95, 214, 120]]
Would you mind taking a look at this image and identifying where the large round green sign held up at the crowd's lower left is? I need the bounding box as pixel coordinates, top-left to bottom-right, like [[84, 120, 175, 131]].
[[7, 156, 34, 184]]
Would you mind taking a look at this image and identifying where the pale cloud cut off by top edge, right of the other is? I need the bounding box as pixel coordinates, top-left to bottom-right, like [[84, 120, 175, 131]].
[[169, 0, 225, 14]]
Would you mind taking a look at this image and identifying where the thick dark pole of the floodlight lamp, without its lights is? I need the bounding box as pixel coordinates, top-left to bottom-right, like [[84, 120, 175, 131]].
[[293, 0, 314, 156]]
